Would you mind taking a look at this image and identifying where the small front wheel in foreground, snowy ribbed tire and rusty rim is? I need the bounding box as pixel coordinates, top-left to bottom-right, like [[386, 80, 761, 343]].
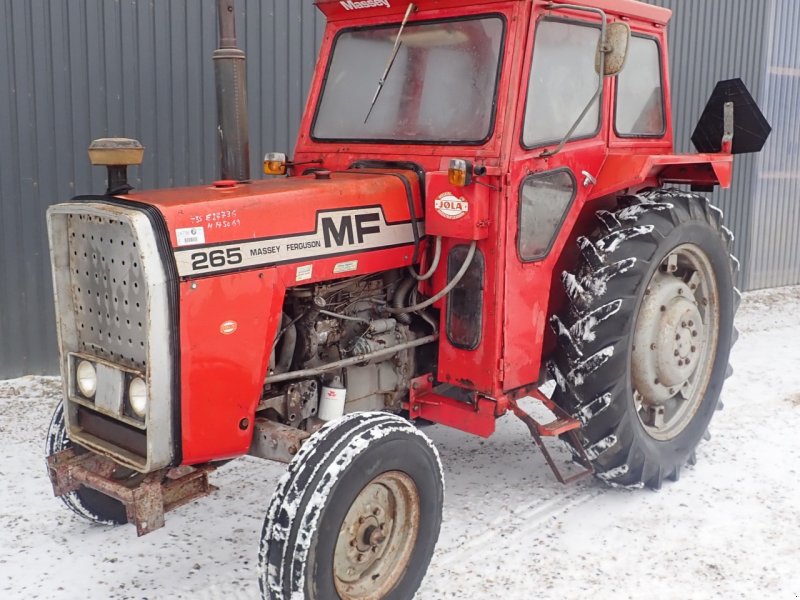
[[259, 413, 444, 600]]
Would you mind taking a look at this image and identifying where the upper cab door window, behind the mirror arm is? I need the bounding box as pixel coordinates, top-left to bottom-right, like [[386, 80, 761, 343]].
[[522, 20, 600, 148]]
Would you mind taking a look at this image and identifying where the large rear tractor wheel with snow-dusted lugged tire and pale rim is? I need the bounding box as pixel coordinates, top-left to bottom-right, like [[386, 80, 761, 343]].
[[550, 190, 740, 489]]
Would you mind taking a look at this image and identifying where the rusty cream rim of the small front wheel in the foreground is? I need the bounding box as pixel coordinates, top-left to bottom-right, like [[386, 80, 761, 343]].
[[333, 471, 420, 600]]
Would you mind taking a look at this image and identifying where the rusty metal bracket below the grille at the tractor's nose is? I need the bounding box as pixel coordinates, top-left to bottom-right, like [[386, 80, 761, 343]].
[[47, 448, 217, 536]]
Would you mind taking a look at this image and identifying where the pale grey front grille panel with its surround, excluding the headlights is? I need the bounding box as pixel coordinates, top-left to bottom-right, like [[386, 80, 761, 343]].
[[48, 202, 175, 472]]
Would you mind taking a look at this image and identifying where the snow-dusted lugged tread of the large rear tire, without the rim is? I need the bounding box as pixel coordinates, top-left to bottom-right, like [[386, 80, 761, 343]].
[[548, 190, 740, 489]]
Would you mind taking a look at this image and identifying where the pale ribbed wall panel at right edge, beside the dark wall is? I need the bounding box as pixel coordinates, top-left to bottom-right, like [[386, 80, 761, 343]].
[[746, 0, 800, 289]]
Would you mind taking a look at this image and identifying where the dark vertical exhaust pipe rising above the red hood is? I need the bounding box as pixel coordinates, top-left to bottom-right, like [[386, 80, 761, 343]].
[[214, 0, 250, 182]]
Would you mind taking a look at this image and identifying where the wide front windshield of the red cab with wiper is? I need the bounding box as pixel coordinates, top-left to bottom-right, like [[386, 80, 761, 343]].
[[312, 16, 504, 144]]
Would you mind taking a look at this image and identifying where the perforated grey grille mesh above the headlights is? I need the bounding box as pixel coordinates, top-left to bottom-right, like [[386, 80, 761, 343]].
[[68, 214, 147, 370]]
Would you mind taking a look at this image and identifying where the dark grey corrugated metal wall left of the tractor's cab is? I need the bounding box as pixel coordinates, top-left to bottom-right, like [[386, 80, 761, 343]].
[[0, 0, 323, 377]]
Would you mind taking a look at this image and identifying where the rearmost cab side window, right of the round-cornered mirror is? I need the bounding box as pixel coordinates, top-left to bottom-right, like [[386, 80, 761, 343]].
[[615, 36, 667, 137]]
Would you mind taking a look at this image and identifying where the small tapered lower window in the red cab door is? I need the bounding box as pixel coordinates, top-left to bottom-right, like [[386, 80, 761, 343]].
[[518, 169, 576, 262]]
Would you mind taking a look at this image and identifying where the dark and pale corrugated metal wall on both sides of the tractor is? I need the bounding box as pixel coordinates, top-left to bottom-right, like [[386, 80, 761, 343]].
[[0, 0, 800, 377]]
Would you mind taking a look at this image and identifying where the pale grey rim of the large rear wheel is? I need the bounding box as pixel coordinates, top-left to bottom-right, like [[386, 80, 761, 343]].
[[631, 244, 720, 441]]
